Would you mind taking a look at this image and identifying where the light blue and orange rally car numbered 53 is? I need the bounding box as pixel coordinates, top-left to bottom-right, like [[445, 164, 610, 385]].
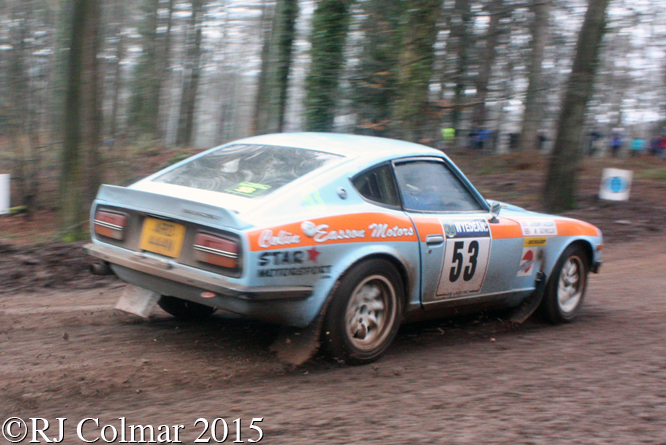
[[86, 133, 603, 364]]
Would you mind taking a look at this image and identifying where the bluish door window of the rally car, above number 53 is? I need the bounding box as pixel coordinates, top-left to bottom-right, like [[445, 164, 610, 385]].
[[396, 161, 484, 212]]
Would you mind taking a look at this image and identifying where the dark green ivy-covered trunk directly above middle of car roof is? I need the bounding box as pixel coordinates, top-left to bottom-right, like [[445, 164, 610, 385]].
[[305, 0, 352, 131]]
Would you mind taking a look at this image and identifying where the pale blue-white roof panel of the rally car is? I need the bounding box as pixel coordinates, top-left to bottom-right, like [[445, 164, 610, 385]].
[[232, 133, 442, 158]]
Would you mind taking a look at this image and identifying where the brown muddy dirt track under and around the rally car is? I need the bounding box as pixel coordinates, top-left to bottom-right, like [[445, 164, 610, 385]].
[[0, 236, 666, 444]]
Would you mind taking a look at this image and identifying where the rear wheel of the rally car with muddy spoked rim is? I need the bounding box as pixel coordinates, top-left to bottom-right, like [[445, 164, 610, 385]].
[[322, 259, 404, 365]]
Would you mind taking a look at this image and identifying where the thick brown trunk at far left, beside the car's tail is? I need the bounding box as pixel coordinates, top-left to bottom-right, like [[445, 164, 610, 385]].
[[60, 0, 100, 241]]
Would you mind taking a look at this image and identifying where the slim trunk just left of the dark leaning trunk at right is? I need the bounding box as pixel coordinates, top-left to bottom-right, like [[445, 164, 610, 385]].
[[518, 0, 550, 151]]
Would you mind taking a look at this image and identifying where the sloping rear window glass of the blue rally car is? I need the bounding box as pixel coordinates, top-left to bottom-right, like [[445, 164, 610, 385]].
[[153, 144, 340, 198]]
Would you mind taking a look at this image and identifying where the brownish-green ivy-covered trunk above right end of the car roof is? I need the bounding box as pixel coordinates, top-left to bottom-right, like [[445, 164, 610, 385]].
[[392, 0, 442, 142]]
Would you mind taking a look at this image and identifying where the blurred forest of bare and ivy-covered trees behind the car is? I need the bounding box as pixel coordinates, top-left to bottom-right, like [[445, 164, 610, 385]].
[[0, 0, 666, 240]]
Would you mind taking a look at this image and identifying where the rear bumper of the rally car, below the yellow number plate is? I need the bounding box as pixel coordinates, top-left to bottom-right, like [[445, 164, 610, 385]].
[[83, 244, 313, 301]]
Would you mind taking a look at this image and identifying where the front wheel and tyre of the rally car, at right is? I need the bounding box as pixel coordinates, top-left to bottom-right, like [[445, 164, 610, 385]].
[[541, 244, 590, 324]]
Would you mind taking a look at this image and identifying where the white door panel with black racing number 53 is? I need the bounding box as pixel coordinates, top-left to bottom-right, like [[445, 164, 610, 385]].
[[437, 237, 490, 297]]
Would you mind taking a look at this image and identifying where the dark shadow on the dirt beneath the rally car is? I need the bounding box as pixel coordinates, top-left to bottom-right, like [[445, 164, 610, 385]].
[[113, 305, 608, 378]]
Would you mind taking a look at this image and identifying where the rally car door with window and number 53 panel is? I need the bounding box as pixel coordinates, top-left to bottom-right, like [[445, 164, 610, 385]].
[[394, 158, 521, 303]]
